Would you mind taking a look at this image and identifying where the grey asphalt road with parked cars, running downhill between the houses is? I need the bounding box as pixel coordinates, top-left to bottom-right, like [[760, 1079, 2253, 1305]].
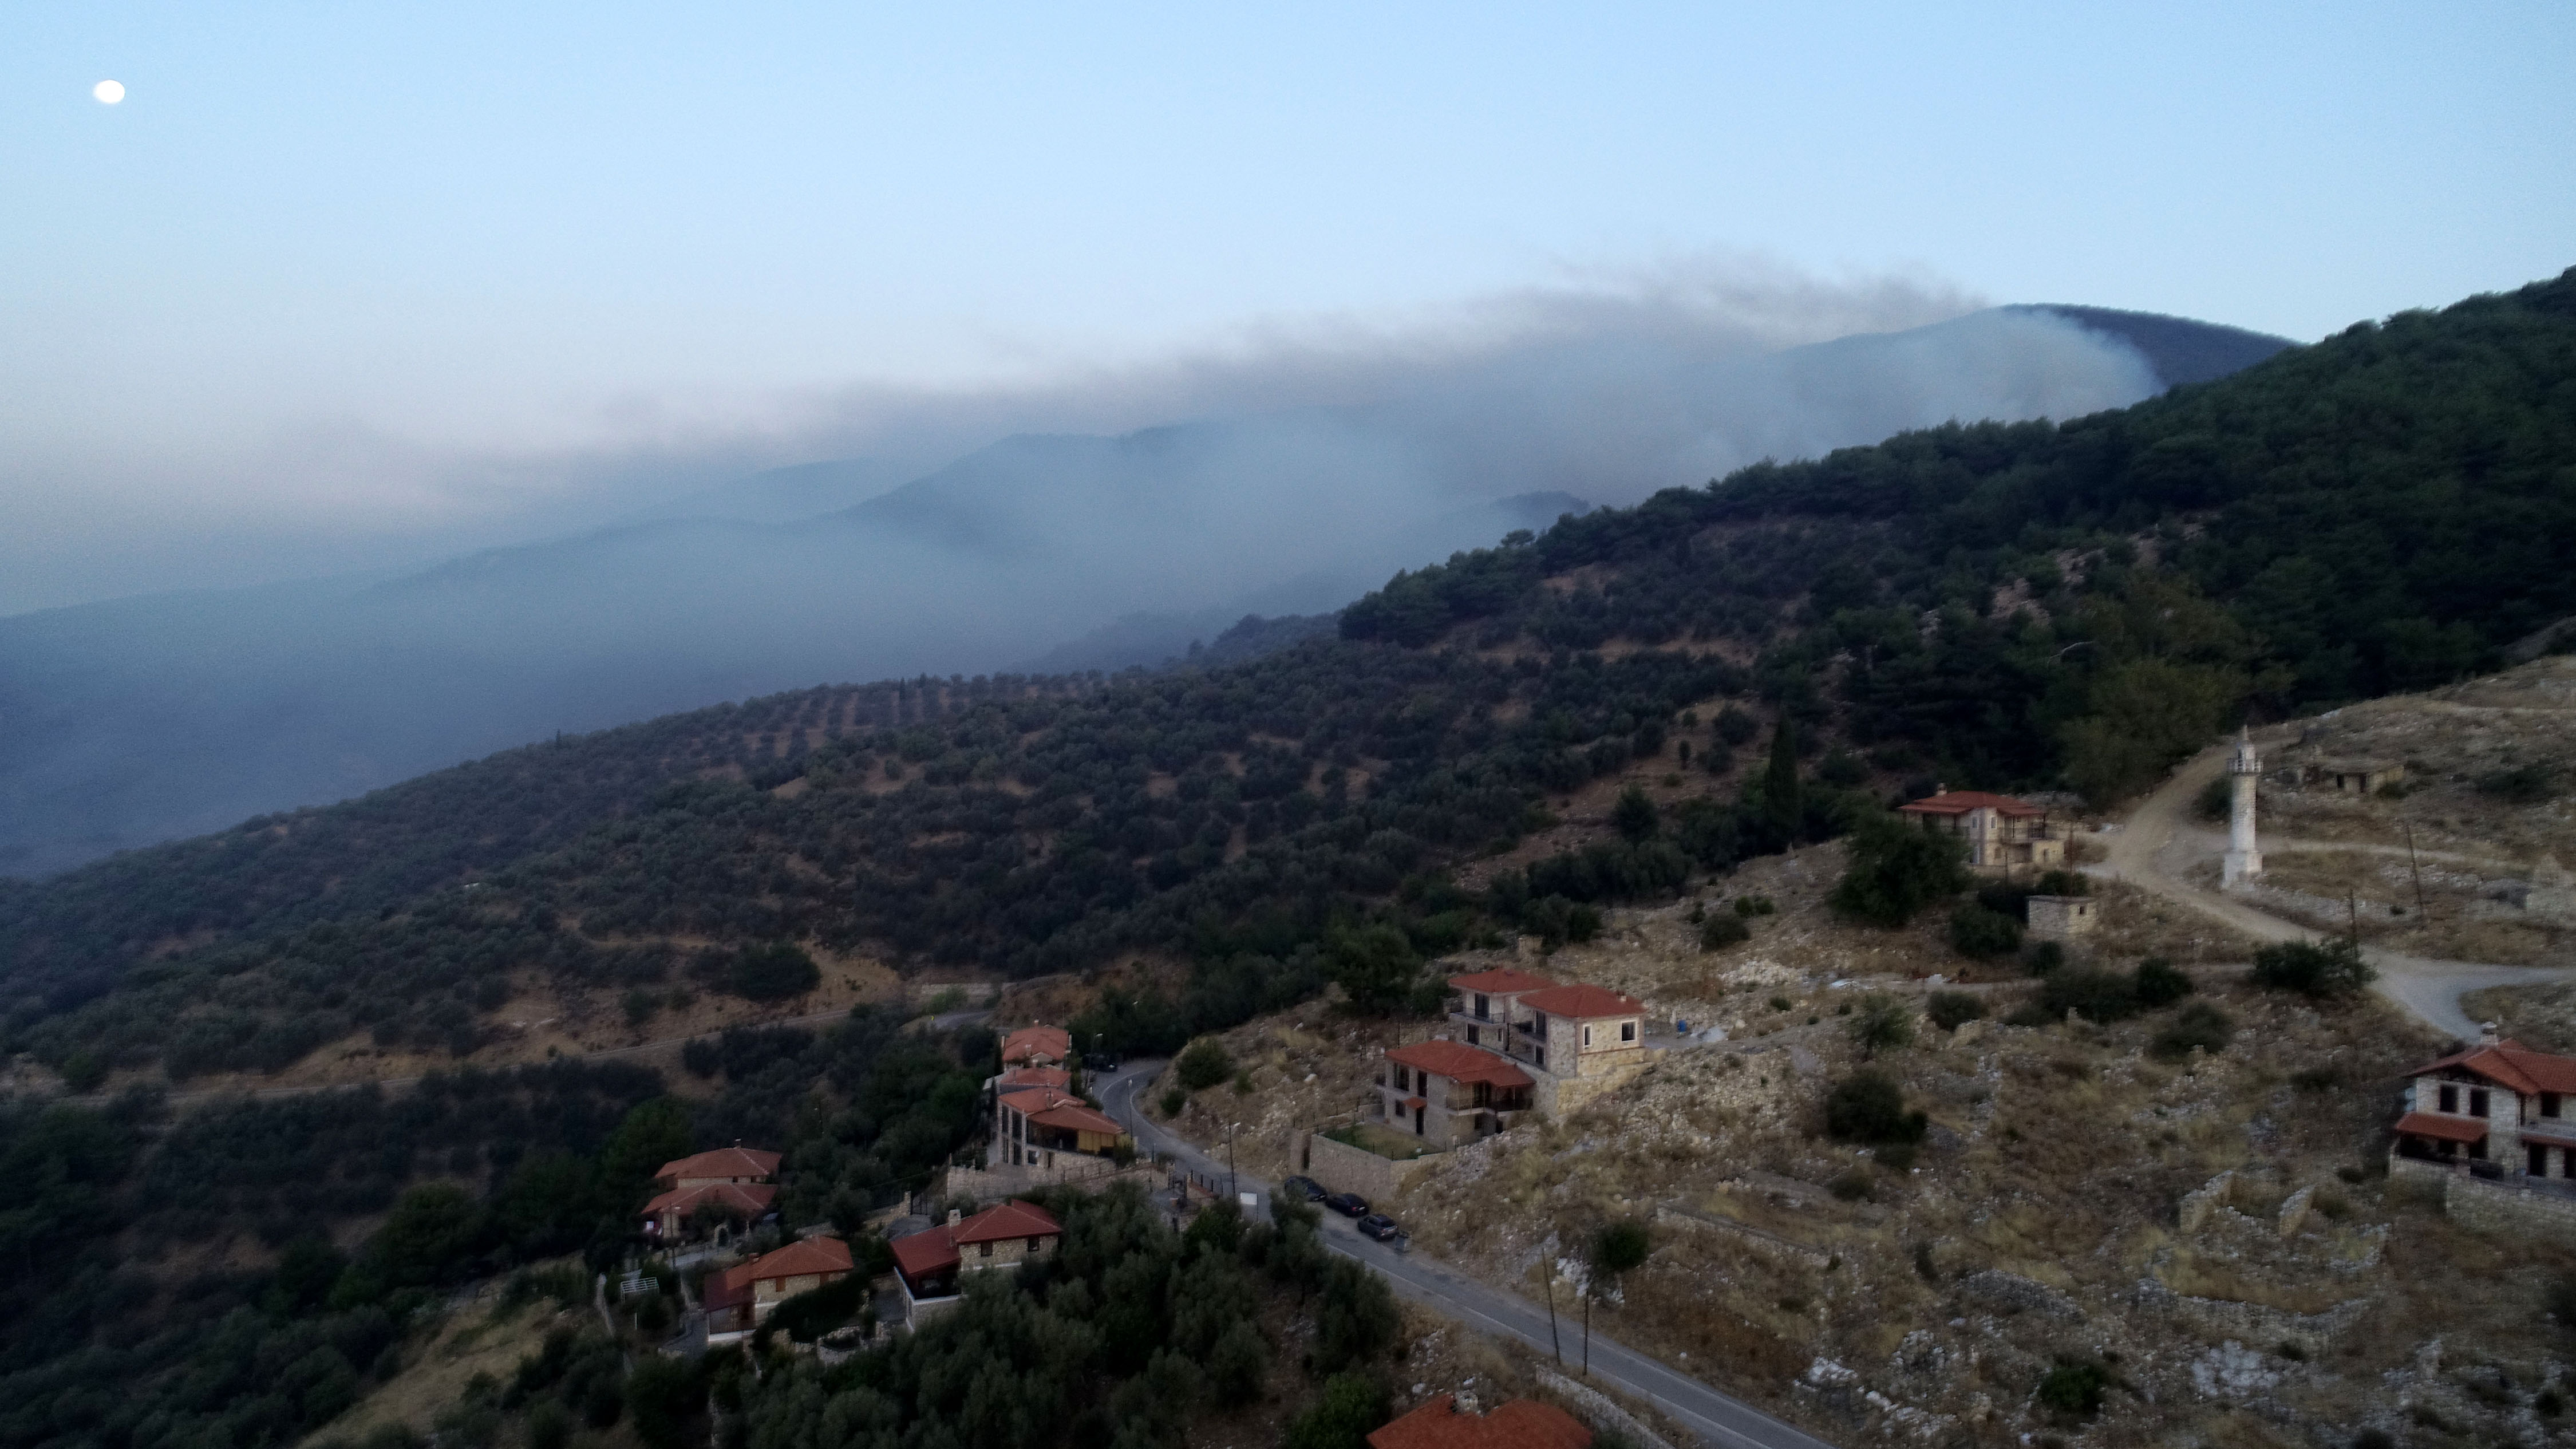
[[1092, 1062, 1827, 1449]]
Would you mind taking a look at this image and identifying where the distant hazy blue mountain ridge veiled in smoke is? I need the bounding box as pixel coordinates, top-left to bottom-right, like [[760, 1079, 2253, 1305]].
[[0, 307, 2282, 874]]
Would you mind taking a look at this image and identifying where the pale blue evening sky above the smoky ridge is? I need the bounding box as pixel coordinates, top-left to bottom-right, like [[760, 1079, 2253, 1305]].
[[0, 0, 2576, 614]]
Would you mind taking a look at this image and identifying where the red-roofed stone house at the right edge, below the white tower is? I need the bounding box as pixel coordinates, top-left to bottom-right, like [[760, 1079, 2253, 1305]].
[[2388, 1026, 2576, 1194]]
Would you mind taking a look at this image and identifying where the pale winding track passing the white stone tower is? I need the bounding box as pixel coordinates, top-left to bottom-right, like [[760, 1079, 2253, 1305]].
[[2084, 743, 2576, 1036]]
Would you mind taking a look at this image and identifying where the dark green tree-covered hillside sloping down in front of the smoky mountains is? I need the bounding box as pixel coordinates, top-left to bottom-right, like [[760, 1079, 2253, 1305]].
[[0, 273, 2576, 1080]]
